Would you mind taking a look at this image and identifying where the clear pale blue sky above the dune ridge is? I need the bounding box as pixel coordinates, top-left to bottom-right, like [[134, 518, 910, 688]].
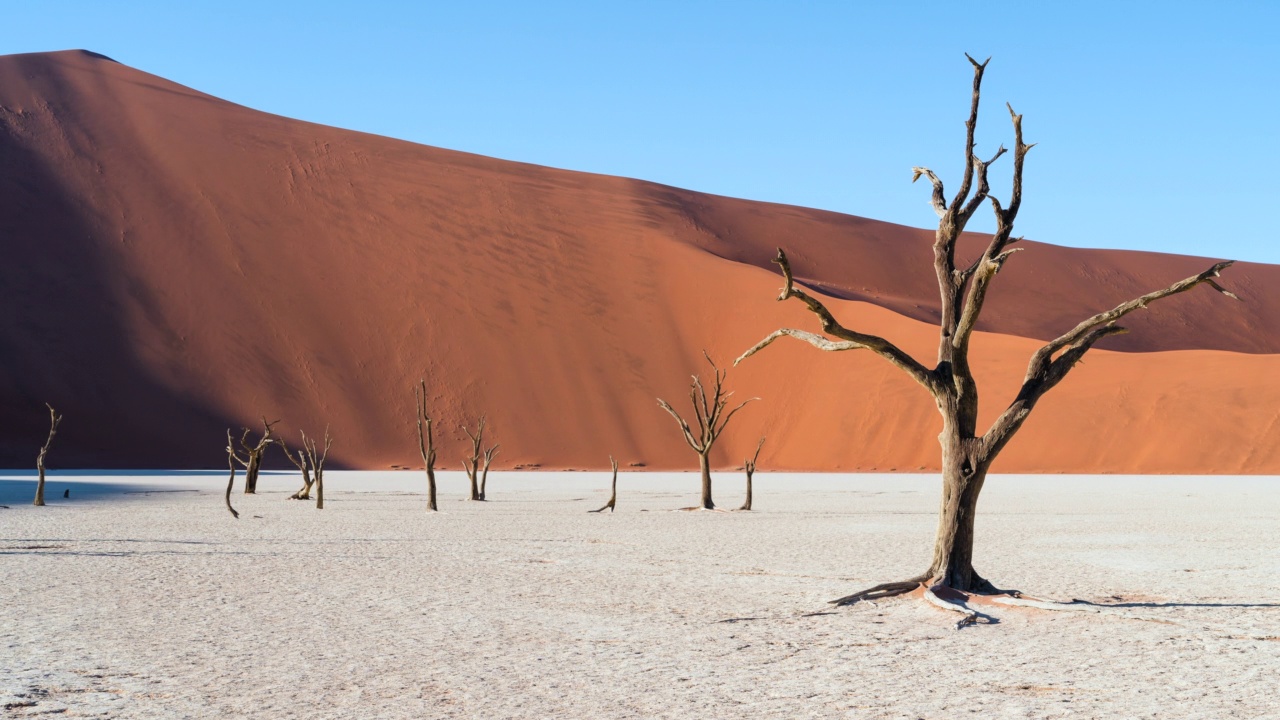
[[0, 0, 1280, 263]]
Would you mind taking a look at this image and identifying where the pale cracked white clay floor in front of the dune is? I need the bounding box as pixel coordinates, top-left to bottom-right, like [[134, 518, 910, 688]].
[[0, 473, 1280, 719]]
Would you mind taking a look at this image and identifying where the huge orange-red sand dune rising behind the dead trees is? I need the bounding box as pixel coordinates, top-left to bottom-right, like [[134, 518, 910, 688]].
[[0, 51, 1280, 473]]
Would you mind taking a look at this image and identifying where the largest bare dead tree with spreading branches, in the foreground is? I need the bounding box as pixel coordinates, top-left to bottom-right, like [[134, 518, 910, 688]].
[[737, 58, 1239, 624]]
